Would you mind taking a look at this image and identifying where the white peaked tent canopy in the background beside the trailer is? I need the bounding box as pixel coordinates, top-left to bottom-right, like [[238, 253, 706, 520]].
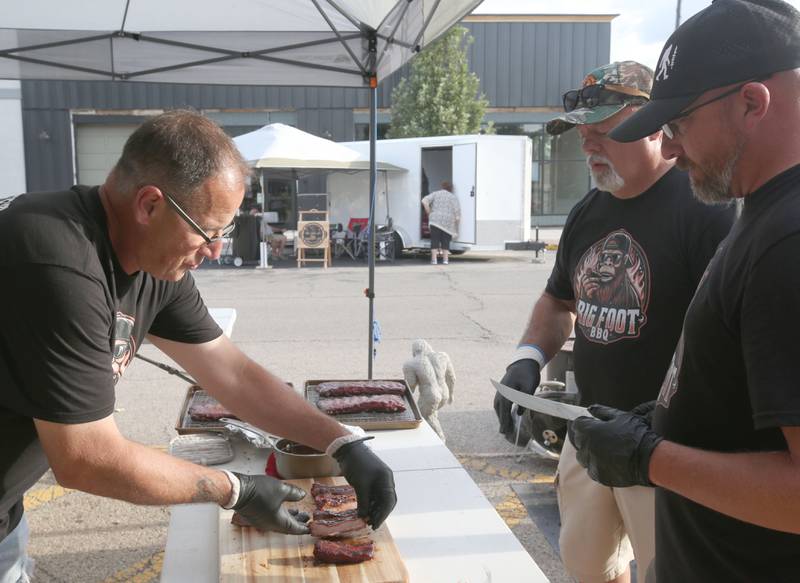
[[233, 123, 404, 172]]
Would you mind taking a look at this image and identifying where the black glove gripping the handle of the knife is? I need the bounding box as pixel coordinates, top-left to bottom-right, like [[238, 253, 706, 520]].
[[569, 405, 663, 488]]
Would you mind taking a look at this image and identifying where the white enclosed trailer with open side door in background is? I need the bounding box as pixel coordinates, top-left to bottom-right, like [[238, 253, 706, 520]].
[[327, 135, 531, 252]]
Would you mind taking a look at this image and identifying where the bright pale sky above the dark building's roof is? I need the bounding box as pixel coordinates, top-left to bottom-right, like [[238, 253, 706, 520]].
[[473, 0, 800, 67]]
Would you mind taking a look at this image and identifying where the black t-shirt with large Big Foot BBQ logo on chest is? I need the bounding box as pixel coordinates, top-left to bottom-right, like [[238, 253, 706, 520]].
[[546, 168, 734, 410]]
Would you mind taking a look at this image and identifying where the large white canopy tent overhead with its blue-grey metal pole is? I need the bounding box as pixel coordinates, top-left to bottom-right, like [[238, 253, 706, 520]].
[[0, 0, 481, 378]]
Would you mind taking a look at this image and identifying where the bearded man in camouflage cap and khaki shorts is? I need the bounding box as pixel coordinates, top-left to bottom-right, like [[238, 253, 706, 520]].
[[494, 61, 734, 583]]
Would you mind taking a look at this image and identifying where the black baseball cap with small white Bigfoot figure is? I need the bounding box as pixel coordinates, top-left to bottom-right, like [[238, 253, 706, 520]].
[[609, 0, 800, 142]]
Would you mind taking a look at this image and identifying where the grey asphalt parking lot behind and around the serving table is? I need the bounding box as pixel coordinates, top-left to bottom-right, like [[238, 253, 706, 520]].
[[26, 252, 571, 583]]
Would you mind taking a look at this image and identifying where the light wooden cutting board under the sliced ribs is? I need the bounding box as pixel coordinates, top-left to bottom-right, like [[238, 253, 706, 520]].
[[219, 477, 408, 583]]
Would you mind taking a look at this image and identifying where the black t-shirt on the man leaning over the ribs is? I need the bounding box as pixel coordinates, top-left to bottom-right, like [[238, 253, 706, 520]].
[[0, 187, 222, 540]]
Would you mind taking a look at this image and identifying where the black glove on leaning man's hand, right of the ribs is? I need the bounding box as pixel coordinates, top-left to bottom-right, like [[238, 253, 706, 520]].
[[333, 440, 397, 530]]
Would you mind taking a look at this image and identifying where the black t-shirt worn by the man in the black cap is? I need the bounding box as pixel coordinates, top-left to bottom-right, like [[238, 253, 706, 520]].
[[653, 166, 800, 583]]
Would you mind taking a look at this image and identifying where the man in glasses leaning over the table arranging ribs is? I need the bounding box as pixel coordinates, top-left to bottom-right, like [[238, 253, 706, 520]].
[[0, 110, 396, 583]]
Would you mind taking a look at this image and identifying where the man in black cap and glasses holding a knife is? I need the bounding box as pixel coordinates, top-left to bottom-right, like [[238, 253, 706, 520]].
[[571, 0, 800, 583]]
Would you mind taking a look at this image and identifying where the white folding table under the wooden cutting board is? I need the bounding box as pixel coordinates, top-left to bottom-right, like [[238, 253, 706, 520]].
[[161, 422, 547, 583]]
